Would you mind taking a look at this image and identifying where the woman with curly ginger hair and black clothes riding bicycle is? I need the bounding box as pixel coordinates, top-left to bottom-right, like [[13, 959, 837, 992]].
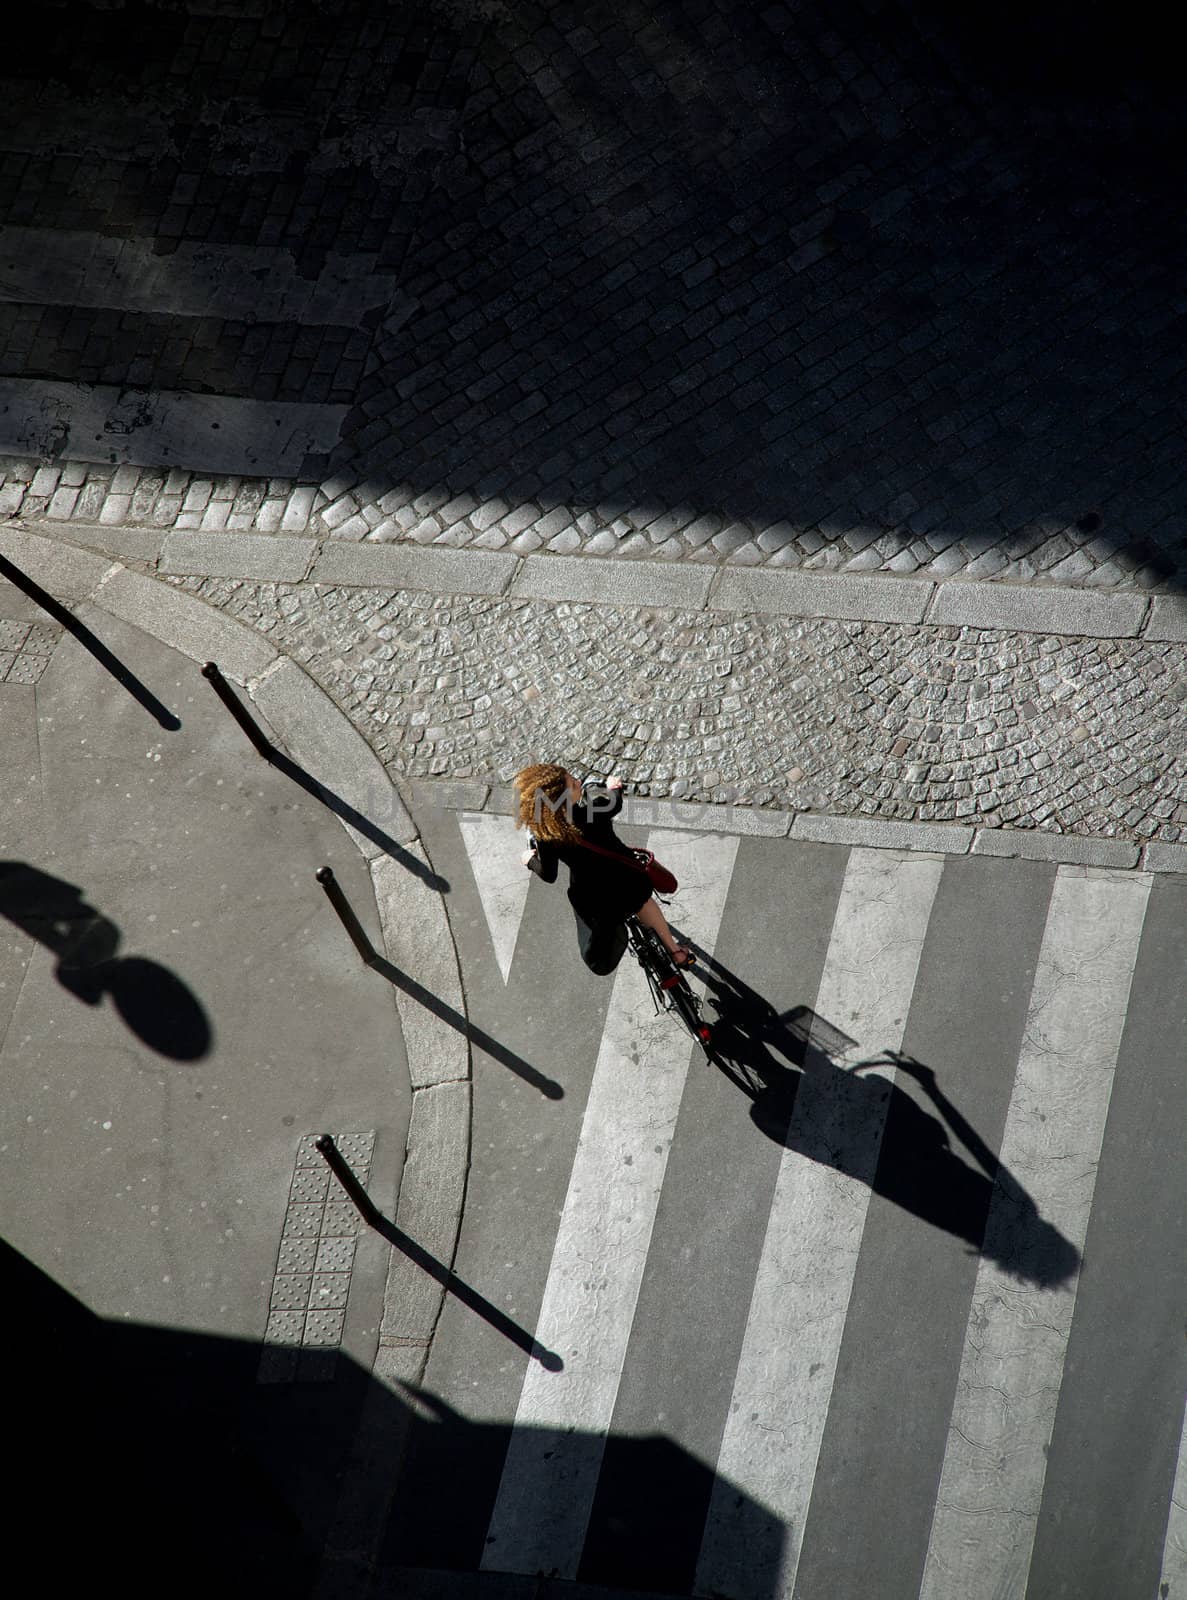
[[515, 762, 696, 978]]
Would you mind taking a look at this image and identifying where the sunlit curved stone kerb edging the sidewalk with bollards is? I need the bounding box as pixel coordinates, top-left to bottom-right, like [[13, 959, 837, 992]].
[[0, 525, 470, 1382]]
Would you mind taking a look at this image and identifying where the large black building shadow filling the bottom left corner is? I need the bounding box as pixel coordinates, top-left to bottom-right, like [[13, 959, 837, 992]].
[[11, 1243, 782, 1600]]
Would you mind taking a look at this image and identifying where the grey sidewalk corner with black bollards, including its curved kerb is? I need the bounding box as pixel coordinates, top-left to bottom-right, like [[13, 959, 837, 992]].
[[0, 546, 469, 1579]]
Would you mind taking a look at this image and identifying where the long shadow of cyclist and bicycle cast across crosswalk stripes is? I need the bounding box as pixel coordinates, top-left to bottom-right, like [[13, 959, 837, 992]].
[[699, 950, 1080, 1288]]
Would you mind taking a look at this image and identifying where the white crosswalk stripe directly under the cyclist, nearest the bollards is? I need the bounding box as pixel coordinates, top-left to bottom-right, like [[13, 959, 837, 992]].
[[483, 834, 737, 1578]]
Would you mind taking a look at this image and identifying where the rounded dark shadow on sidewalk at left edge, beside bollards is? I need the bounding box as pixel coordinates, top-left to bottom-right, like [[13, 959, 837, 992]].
[[0, 861, 213, 1061]]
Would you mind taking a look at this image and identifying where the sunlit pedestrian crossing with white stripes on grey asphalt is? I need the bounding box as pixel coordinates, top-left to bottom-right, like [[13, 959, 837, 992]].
[[386, 816, 1187, 1600]]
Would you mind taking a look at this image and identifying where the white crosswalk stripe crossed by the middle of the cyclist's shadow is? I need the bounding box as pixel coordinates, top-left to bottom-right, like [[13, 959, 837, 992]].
[[697, 850, 942, 1595]]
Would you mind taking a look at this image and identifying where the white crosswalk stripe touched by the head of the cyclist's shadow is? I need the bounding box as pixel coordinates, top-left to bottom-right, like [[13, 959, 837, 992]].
[[921, 867, 1150, 1600]]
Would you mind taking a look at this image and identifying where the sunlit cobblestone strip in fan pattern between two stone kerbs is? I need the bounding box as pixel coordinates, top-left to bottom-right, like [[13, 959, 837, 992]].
[[170, 578, 1187, 843]]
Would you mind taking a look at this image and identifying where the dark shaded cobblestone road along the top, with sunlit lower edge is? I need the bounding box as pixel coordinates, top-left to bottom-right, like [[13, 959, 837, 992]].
[[0, 0, 1187, 588]]
